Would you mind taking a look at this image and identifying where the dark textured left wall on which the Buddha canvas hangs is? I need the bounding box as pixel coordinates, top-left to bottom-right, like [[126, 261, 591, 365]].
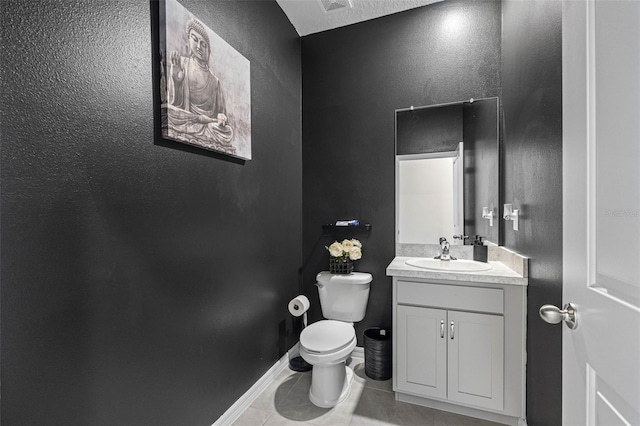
[[0, 0, 302, 426]]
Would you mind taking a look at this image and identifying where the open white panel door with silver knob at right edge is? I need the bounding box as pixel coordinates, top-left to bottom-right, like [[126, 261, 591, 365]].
[[562, 0, 640, 426]]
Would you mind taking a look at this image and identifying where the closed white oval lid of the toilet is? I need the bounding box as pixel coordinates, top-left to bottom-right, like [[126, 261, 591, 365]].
[[300, 320, 356, 352]]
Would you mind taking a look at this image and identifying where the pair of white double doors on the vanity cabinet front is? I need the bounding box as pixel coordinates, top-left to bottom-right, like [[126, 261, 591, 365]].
[[397, 305, 504, 410]]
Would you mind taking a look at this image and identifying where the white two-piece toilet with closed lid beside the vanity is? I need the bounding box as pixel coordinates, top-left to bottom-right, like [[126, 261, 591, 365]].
[[300, 271, 373, 408]]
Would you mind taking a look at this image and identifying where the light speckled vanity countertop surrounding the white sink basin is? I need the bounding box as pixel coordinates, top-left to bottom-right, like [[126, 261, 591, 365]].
[[387, 256, 529, 286]]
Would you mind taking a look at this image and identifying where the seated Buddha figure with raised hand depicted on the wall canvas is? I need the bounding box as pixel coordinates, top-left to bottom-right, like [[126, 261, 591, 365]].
[[166, 18, 235, 155]]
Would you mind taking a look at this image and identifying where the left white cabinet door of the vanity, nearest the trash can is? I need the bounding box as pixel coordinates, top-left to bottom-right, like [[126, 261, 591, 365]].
[[396, 305, 447, 399]]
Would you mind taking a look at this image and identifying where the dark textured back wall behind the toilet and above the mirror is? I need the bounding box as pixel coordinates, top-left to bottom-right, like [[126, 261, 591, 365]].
[[302, 0, 501, 345]]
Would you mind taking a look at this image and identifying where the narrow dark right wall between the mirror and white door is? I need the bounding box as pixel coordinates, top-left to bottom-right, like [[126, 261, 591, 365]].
[[502, 1, 562, 426]]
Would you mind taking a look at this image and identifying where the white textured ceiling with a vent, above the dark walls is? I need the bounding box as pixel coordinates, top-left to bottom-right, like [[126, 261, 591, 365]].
[[276, 0, 442, 36]]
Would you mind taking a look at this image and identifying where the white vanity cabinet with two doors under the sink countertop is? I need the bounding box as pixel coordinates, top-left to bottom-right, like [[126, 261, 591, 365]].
[[393, 270, 526, 425]]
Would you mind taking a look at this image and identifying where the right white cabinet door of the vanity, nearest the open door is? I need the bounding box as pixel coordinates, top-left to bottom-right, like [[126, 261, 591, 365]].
[[447, 311, 504, 410]]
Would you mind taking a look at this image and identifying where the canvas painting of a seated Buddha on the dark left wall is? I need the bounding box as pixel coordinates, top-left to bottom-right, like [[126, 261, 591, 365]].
[[161, 0, 251, 159]]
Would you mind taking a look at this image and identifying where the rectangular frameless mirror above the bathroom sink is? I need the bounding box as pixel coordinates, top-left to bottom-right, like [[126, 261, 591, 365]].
[[396, 98, 501, 244]]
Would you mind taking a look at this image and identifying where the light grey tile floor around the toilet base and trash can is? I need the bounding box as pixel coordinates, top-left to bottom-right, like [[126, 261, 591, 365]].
[[234, 358, 498, 426]]
